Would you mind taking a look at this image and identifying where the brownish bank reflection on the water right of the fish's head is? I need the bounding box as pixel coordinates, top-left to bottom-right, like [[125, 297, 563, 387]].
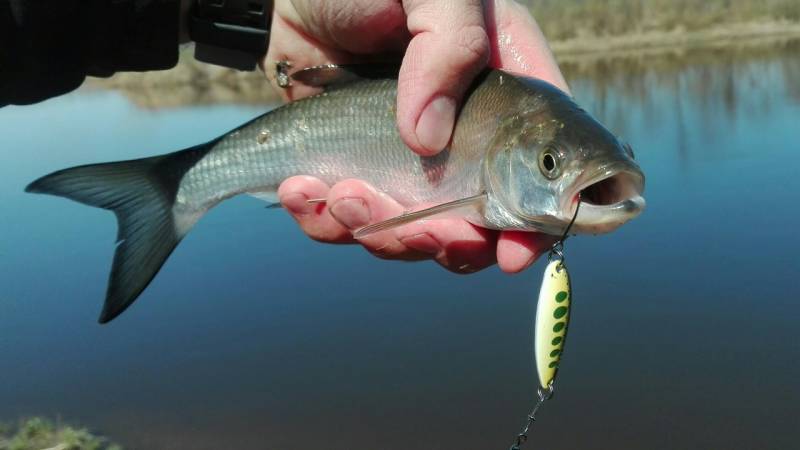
[[562, 40, 800, 130]]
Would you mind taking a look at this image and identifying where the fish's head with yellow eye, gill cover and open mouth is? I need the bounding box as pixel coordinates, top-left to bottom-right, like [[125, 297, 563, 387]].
[[484, 81, 645, 235]]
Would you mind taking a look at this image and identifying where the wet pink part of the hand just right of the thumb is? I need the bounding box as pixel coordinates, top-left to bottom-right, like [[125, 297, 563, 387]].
[[486, 0, 569, 93]]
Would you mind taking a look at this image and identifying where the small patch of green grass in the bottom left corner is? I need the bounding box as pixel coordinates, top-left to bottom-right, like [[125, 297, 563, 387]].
[[0, 417, 122, 450]]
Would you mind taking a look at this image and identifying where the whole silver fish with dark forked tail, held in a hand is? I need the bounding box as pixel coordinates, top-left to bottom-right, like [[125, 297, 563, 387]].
[[26, 66, 645, 323]]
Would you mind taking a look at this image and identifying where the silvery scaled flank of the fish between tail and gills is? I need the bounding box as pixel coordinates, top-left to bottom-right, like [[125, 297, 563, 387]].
[[177, 76, 498, 211]]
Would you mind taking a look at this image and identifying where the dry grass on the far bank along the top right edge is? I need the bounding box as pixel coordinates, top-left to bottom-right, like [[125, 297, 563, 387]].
[[523, 0, 800, 40]]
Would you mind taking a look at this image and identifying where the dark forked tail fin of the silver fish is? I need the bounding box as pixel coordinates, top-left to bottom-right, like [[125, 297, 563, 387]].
[[25, 143, 212, 323]]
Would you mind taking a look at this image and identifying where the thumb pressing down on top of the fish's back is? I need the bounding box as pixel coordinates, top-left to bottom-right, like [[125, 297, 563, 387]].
[[397, 0, 489, 155]]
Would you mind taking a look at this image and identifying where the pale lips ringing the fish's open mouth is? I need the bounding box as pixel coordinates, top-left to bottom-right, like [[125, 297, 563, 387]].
[[562, 161, 645, 225]]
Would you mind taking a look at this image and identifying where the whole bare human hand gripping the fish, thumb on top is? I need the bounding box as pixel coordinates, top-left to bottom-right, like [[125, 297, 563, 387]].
[[263, 0, 568, 273]]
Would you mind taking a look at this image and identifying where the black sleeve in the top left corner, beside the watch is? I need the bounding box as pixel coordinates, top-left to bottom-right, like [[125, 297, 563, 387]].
[[0, 0, 180, 106]]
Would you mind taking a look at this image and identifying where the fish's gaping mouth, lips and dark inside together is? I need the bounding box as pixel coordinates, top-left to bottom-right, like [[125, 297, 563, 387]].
[[563, 162, 645, 234]]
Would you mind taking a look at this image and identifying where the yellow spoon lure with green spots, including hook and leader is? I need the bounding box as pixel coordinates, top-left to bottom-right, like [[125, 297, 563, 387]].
[[510, 196, 581, 450]]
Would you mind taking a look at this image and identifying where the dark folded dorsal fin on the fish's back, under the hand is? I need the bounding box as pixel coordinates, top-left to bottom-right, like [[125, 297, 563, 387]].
[[291, 63, 400, 87]]
